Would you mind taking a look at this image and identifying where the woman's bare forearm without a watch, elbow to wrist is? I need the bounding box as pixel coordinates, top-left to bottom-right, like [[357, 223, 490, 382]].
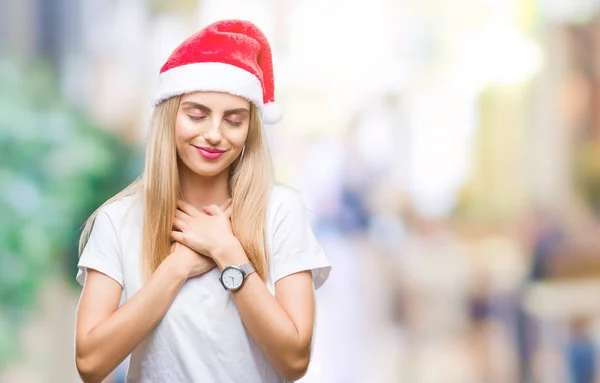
[[77, 262, 186, 382]]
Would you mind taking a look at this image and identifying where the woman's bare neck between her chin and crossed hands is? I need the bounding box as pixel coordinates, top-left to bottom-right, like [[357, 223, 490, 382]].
[[179, 163, 229, 209]]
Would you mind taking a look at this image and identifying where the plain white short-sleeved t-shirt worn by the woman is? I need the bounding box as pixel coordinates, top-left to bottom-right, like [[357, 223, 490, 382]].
[[77, 186, 331, 383]]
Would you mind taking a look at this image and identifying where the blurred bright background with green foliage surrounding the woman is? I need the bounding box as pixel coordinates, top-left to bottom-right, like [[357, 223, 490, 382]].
[[0, 0, 600, 383]]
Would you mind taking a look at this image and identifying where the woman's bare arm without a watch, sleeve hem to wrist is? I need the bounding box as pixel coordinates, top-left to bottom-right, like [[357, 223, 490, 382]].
[[75, 258, 187, 382]]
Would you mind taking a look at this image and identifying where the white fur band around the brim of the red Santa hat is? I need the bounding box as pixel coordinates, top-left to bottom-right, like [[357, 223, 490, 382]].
[[154, 62, 267, 108]]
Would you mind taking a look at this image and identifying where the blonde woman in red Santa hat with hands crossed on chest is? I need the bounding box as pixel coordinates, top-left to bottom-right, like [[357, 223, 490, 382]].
[[76, 20, 330, 383]]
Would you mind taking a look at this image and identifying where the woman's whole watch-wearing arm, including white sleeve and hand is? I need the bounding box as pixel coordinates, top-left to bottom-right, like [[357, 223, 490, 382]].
[[171, 195, 330, 380]]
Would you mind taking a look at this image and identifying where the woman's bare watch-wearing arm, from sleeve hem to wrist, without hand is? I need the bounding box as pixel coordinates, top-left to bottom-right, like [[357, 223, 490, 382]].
[[213, 241, 315, 380]]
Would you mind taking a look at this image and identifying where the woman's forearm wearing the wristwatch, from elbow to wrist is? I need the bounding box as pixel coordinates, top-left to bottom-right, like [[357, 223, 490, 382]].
[[217, 242, 310, 380]]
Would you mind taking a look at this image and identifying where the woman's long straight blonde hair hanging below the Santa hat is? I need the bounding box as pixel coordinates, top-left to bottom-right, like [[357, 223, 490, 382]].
[[79, 96, 273, 280]]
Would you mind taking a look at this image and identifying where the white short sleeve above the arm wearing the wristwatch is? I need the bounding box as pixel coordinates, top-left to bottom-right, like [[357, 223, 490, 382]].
[[271, 191, 331, 289]]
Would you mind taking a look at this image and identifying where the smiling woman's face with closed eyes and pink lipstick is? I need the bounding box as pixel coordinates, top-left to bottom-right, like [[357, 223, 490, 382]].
[[175, 92, 250, 177]]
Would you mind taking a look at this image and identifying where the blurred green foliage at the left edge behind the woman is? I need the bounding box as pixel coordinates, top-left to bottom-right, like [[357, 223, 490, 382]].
[[0, 61, 139, 369]]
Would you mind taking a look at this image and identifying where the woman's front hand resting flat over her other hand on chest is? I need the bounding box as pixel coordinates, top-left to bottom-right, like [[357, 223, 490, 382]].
[[171, 200, 237, 259]]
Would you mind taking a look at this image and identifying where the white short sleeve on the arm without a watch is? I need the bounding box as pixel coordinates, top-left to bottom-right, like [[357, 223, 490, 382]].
[[76, 210, 123, 286]]
